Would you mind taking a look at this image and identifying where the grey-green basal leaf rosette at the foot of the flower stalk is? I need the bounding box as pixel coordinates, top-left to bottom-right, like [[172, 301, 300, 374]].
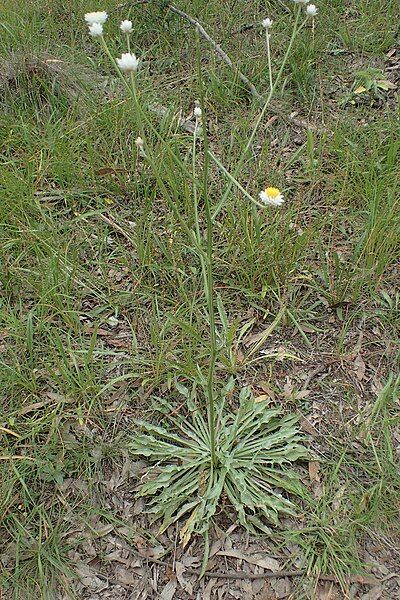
[[131, 379, 308, 544]]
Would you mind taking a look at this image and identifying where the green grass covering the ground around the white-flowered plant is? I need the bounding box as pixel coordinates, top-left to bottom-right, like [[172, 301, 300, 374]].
[[0, 0, 400, 598]]
